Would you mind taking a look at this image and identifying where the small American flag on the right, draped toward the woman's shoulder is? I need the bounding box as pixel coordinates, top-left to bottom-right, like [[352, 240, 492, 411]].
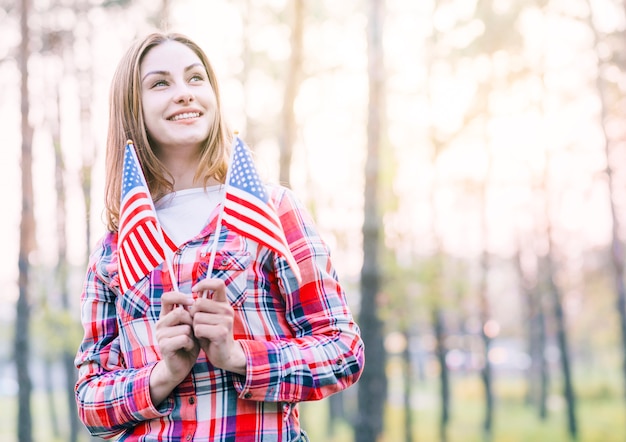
[[222, 137, 301, 282]]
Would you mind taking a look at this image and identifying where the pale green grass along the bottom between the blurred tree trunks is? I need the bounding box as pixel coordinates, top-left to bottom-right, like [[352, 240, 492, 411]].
[[0, 377, 626, 442]]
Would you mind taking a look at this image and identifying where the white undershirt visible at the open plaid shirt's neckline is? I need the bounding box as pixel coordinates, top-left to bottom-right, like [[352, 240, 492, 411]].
[[155, 185, 224, 245]]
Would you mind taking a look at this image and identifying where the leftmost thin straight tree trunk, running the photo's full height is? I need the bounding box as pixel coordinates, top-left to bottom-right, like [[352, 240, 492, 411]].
[[14, 0, 35, 442]]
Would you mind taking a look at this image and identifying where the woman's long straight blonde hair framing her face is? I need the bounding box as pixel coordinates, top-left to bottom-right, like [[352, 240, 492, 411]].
[[105, 33, 232, 232]]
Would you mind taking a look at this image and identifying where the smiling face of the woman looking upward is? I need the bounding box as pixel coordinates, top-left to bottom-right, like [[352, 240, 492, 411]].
[[140, 41, 217, 153]]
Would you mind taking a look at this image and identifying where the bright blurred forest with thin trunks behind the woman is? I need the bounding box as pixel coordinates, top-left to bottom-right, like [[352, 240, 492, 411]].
[[0, 0, 626, 442]]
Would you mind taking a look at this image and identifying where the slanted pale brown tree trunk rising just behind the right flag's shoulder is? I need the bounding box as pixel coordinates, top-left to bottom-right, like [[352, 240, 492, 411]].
[[279, 0, 304, 186]]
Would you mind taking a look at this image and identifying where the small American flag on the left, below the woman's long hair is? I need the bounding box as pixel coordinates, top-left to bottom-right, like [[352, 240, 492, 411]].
[[118, 141, 177, 293]]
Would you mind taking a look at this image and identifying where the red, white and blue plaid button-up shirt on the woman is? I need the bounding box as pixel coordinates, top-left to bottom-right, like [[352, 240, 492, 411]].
[[76, 187, 364, 442]]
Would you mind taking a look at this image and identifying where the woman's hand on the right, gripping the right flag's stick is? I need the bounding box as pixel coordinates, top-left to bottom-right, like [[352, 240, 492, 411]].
[[189, 278, 246, 375]]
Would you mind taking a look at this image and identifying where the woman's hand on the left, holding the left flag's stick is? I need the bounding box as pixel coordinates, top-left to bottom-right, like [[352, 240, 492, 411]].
[[150, 292, 200, 406]]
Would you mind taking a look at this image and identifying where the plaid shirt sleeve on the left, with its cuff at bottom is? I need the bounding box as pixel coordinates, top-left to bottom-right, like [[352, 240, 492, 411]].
[[75, 235, 173, 439]]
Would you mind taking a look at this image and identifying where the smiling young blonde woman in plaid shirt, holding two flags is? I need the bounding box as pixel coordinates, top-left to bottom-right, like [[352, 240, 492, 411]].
[[76, 34, 364, 442]]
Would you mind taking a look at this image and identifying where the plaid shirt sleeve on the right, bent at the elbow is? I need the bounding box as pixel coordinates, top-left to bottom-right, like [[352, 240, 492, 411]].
[[235, 188, 364, 403]]
